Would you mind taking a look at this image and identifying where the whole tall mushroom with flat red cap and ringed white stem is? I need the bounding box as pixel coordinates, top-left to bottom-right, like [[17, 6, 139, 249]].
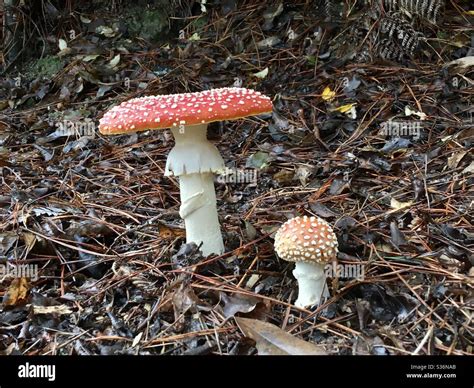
[[99, 88, 272, 255]]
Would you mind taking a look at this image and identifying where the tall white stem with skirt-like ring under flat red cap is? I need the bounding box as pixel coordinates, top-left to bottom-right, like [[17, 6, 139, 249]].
[[165, 124, 224, 256]]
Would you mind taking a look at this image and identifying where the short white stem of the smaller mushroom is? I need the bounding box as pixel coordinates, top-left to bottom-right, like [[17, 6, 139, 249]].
[[293, 261, 329, 308]]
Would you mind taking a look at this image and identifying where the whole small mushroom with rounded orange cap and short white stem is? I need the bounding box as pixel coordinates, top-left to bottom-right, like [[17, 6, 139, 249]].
[[275, 216, 337, 308]]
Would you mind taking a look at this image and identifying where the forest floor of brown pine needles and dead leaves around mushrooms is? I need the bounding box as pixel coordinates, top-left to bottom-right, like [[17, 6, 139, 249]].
[[0, 1, 474, 355]]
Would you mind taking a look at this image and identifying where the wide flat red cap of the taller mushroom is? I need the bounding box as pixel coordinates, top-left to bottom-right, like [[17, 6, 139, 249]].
[[99, 88, 272, 135]]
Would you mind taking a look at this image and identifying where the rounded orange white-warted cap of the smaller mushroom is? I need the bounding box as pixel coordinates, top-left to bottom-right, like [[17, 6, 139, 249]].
[[275, 216, 337, 264]]
